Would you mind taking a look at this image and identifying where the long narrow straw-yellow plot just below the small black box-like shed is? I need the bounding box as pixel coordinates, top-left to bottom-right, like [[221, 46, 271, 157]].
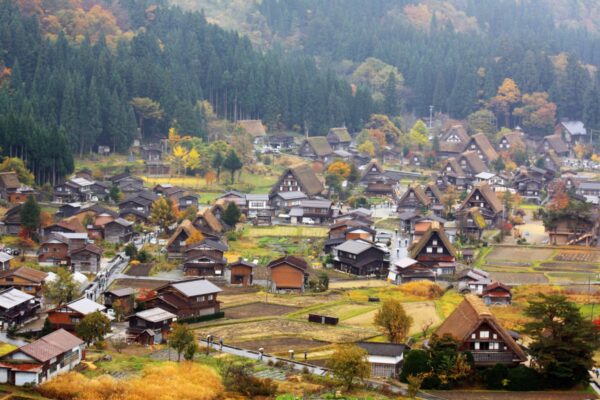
[[197, 319, 377, 343]]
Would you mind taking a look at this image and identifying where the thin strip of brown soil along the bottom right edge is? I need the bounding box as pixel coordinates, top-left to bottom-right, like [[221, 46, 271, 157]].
[[430, 390, 598, 400]]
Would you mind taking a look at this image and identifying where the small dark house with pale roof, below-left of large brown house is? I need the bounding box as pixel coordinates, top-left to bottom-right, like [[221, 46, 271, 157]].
[[127, 307, 177, 346]]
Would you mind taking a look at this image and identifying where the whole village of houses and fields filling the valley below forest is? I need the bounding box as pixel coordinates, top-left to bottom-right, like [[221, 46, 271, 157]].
[[0, 116, 600, 399]]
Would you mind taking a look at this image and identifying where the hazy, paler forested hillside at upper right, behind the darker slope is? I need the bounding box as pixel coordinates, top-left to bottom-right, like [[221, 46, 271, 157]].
[[174, 0, 600, 128]]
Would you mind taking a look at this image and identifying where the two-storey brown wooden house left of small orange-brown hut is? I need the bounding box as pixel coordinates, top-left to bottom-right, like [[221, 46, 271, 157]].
[[183, 239, 228, 276]]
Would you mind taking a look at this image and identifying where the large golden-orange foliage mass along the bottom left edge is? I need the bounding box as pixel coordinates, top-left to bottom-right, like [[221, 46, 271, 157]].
[[39, 362, 223, 400]]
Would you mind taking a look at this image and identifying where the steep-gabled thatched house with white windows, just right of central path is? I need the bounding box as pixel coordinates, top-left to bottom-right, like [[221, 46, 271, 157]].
[[408, 221, 456, 275]]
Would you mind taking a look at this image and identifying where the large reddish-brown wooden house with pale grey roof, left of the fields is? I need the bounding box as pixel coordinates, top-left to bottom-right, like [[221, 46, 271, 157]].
[[143, 278, 221, 319]]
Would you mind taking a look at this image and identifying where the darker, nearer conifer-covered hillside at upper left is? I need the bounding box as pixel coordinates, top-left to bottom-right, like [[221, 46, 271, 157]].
[[0, 0, 372, 182]]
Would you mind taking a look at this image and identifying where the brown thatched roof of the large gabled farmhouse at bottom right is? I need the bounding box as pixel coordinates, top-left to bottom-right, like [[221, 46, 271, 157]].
[[435, 294, 527, 361]]
